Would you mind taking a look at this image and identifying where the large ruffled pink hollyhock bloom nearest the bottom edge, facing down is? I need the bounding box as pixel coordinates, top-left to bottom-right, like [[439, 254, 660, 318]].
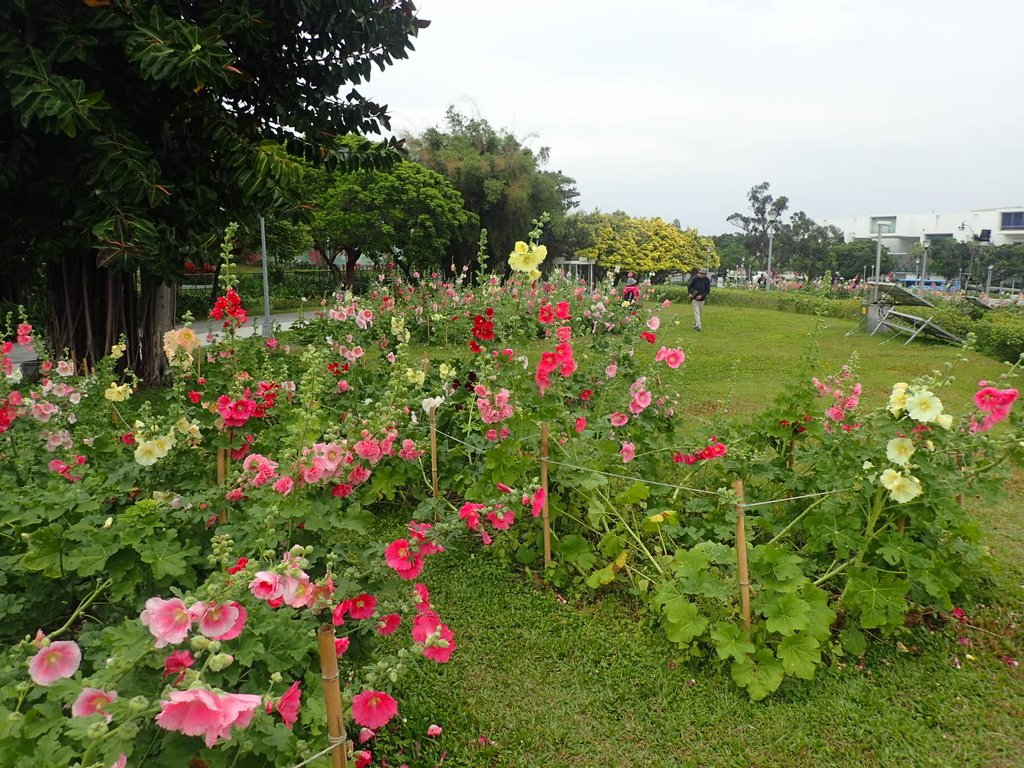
[[155, 688, 262, 746]]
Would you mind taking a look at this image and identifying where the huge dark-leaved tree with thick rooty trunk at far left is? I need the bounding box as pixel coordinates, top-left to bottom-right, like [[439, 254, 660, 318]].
[[0, 0, 427, 378]]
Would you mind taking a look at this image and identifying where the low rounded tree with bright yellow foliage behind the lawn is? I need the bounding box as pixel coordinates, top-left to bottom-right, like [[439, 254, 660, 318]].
[[577, 211, 719, 273]]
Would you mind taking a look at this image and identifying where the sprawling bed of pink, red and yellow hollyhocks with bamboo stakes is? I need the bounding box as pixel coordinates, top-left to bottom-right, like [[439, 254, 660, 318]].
[[0, 231, 1022, 765]]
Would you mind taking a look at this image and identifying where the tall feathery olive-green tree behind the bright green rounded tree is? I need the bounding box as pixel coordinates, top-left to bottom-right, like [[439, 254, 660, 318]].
[[407, 106, 579, 268]]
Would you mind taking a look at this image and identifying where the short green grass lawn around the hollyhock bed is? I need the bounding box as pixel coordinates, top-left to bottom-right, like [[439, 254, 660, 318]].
[[369, 304, 1024, 768]]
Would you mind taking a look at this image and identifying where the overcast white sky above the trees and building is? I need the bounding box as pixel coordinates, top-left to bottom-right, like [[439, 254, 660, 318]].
[[359, 0, 1024, 234]]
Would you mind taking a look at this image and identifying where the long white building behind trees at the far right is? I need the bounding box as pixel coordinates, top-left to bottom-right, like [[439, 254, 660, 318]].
[[820, 206, 1024, 256]]
